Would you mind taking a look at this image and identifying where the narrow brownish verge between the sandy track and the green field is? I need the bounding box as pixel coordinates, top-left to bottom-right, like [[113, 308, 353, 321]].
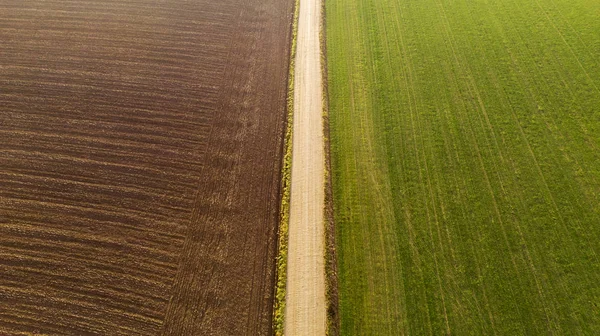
[[319, 1, 340, 336]]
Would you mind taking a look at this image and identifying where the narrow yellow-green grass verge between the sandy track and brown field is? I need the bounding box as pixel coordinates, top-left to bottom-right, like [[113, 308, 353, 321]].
[[273, 0, 300, 336]]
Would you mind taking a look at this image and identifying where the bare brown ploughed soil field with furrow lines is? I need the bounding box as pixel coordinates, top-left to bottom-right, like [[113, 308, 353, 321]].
[[0, 0, 293, 335]]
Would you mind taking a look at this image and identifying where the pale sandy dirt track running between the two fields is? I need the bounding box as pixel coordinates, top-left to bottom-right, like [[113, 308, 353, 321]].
[[285, 0, 326, 336]]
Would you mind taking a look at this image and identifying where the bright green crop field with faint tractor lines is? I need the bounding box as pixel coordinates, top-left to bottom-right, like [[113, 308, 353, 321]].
[[325, 0, 600, 335]]
